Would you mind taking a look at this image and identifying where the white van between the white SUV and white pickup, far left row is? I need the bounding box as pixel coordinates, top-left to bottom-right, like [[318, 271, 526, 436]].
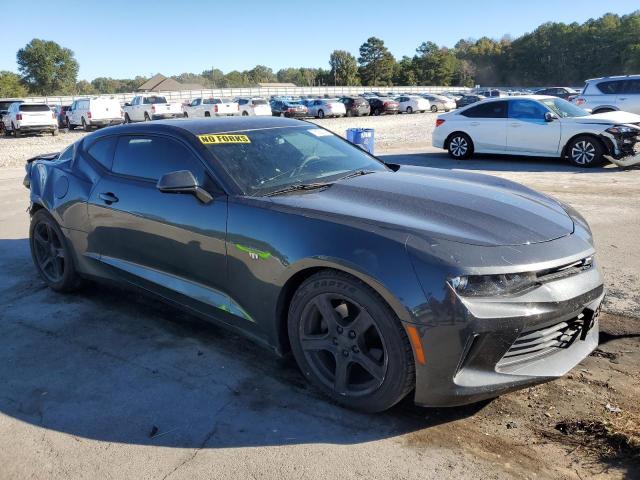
[[65, 97, 124, 130]]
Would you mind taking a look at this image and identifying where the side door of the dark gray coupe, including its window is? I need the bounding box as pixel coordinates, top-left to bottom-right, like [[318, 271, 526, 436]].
[[88, 131, 232, 315]]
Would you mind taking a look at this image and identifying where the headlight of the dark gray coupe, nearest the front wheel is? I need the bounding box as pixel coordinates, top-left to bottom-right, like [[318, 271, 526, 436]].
[[449, 272, 537, 297]]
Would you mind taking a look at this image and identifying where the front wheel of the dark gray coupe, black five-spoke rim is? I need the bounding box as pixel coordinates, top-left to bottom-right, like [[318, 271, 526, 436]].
[[287, 270, 415, 412]]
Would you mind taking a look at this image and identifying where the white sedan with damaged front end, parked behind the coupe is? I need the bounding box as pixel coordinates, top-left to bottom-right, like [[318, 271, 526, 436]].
[[432, 95, 640, 167]]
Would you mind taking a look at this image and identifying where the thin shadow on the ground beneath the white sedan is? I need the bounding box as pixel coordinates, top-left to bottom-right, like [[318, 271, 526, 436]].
[[380, 149, 623, 174]]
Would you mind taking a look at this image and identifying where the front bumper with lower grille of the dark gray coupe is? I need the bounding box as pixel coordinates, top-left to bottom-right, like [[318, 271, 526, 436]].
[[415, 267, 604, 406]]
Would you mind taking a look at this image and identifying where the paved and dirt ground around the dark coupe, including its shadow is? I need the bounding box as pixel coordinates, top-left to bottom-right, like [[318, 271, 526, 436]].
[[0, 129, 640, 480]]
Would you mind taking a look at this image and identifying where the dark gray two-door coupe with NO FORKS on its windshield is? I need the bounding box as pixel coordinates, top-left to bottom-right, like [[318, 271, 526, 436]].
[[25, 117, 604, 411]]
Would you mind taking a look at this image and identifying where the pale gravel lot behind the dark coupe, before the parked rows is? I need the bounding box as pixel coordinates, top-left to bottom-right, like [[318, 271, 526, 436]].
[[0, 113, 436, 168]]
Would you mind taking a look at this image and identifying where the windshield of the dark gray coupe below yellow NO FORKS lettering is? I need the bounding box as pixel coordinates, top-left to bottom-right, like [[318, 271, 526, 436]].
[[205, 125, 387, 196]]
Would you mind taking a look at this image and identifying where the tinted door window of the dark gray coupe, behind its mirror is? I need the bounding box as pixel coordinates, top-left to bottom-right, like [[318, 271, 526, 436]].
[[112, 135, 203, 180]]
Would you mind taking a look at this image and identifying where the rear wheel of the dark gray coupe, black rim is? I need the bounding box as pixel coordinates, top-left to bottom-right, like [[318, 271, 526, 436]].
[[29, 209, 82, 292]]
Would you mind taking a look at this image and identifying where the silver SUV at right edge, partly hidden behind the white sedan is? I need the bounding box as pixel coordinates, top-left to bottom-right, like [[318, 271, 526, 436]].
[[572, 75, 640, 114]]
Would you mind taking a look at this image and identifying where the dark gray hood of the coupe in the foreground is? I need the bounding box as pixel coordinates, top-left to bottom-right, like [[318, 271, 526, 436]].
[[270, 167, 574, 246]]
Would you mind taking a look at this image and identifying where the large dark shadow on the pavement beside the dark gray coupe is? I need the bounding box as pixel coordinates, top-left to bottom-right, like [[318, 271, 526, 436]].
[[0, 239, 486, 448]]
